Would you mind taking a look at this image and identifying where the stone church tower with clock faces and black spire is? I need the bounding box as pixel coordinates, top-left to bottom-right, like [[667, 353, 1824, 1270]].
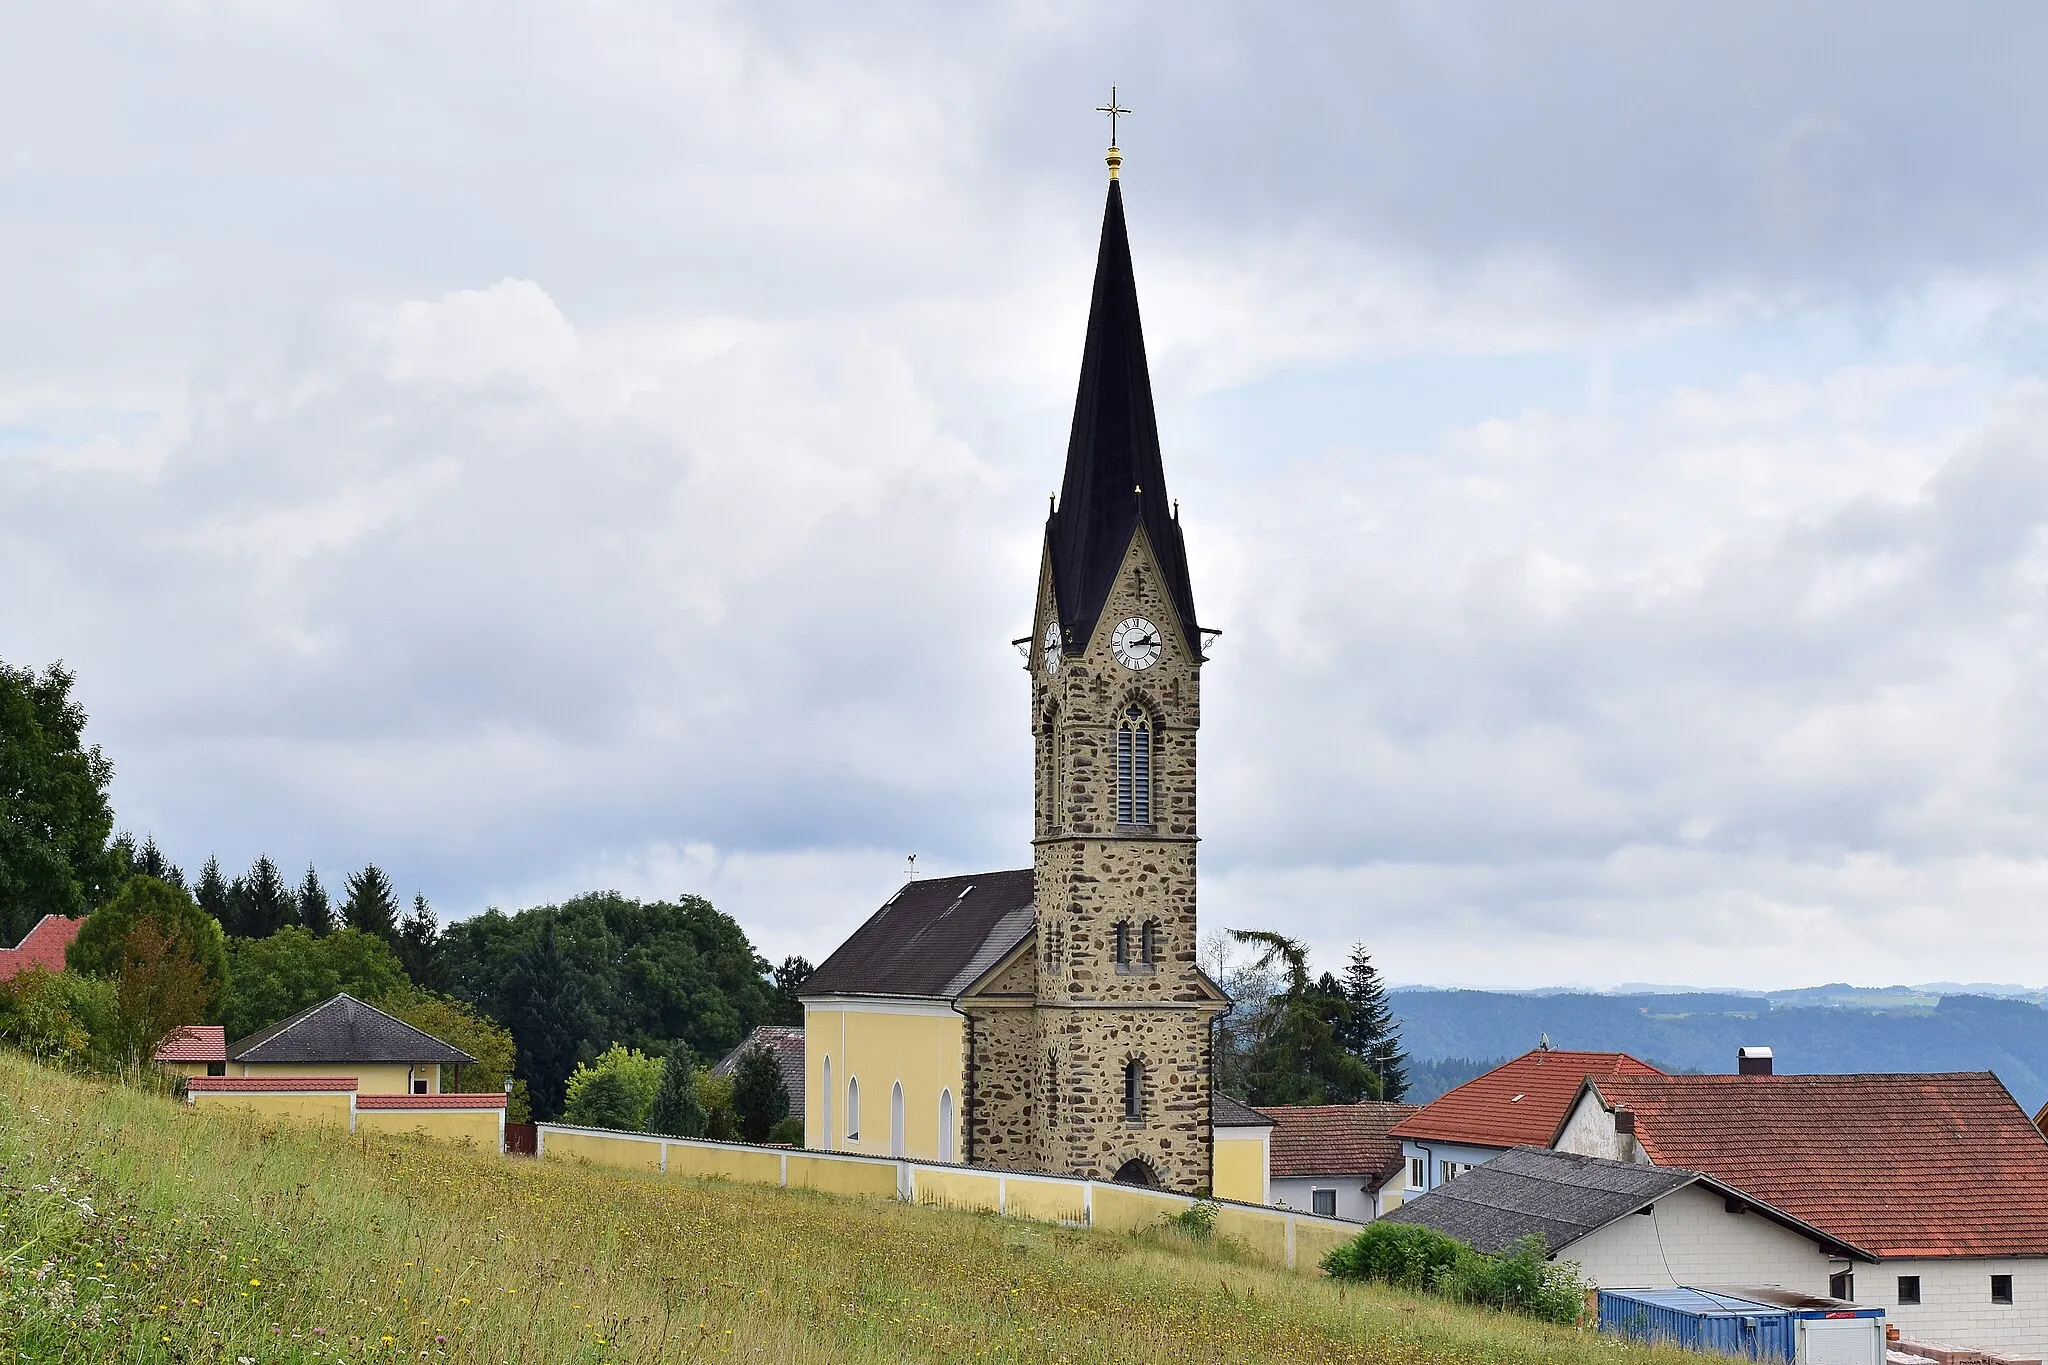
[[1028, 136, 1227, 1191]]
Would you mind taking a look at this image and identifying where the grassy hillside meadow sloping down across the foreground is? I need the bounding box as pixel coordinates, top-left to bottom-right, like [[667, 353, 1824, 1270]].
[[0, 1054, 1686, 1365]]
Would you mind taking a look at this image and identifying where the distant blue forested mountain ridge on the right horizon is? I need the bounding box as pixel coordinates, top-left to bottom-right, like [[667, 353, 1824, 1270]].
[[1389, 984, 2048, 1113]]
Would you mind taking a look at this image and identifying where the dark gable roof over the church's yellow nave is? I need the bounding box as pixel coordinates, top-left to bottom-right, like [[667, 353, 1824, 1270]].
[[799, 868, 1036, 1001]]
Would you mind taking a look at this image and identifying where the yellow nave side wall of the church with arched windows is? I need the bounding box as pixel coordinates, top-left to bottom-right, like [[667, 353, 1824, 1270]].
[[803, 1005, 967, 1160]]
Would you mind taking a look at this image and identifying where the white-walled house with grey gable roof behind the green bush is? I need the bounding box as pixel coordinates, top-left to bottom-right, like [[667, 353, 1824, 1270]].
[[1386, 1146, 1876, 1293]]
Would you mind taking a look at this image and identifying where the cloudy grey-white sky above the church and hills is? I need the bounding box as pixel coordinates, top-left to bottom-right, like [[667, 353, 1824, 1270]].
[[0, 0, 2048, 986]]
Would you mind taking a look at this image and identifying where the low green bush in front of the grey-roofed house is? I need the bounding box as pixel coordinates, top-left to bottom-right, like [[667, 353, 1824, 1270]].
[[1323, 1222, 1585, 1324]]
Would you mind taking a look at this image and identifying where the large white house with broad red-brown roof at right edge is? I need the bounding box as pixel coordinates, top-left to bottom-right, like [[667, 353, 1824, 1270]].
[[1552, 1058, 2048, 1359]]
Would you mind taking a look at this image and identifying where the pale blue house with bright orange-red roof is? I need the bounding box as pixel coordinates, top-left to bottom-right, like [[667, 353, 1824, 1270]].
[[1391, 1042, 1663, 1197]]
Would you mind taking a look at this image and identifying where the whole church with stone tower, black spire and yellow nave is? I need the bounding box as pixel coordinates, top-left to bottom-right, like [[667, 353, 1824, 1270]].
[[803, 130, 1268, 1201]]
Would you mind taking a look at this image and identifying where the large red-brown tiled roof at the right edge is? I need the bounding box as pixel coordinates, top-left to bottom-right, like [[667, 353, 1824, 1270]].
[[1593, 1070, 2048, 1257]]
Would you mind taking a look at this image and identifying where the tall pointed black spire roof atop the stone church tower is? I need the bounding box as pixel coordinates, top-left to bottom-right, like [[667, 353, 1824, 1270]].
[[1044, 175, 1198, 649]]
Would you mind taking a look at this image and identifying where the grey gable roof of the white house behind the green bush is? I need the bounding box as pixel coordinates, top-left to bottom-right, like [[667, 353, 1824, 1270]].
[[1382, 1146, 1876, 1261]]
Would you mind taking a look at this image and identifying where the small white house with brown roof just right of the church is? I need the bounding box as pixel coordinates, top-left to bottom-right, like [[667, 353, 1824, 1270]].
[[1260, 1099, 1417, 1222]]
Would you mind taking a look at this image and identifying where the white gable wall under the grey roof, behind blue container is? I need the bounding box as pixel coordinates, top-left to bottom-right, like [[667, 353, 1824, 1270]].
[[1556, 1185, 1835, 1293]]
